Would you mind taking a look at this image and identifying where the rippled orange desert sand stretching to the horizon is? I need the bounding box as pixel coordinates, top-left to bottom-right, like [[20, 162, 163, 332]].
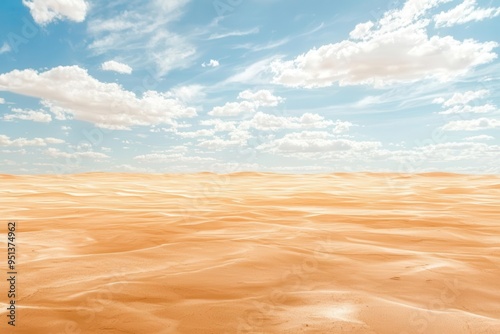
[[0, 173, 500, 334]]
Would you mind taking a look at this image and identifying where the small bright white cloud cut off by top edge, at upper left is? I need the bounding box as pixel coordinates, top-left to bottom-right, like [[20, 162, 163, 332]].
[[23, 0, 89, 25]]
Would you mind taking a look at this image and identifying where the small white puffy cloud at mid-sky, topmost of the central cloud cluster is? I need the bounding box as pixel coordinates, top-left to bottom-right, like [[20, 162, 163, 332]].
[[208, 89, 284, 116]]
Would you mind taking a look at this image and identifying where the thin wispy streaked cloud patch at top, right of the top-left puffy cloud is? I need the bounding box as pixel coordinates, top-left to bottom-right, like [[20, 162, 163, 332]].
[[88, 0, 196, 76]]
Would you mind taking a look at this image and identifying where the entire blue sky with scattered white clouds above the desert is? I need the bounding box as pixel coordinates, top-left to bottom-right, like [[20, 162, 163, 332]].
[[0, 0, 500, 174]]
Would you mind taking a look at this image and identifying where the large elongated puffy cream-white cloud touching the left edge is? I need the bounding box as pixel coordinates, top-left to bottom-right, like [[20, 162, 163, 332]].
[[0, 66, 196, 129]]
